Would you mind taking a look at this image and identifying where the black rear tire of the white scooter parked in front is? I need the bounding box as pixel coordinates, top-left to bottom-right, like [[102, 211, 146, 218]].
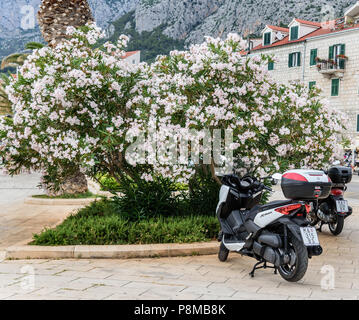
[[278, 234, 308, 282]]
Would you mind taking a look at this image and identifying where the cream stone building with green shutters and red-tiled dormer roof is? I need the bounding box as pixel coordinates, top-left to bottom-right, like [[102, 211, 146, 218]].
[[249, 1, 359, 146]]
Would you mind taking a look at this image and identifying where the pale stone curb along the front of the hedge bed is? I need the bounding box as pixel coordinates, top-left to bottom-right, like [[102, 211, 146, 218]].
[[5, 241, 219, 259]]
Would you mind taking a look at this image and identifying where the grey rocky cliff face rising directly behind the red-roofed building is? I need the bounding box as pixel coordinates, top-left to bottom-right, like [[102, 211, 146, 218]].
[[136, 0, 356, 43]]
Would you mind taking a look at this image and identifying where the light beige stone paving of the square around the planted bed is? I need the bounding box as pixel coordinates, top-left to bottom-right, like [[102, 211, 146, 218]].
[[0, 172, 359, 300]]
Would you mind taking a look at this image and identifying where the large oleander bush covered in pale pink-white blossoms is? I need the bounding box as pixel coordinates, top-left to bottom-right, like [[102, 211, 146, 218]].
[[0, 24, 344, 228]]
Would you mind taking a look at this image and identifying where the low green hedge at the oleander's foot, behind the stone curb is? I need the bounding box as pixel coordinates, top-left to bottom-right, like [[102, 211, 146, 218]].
[[31, 200, 219, 245]]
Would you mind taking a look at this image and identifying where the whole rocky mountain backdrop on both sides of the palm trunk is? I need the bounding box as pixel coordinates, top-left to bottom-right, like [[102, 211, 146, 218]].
[[0, 0, 356, 62]]
